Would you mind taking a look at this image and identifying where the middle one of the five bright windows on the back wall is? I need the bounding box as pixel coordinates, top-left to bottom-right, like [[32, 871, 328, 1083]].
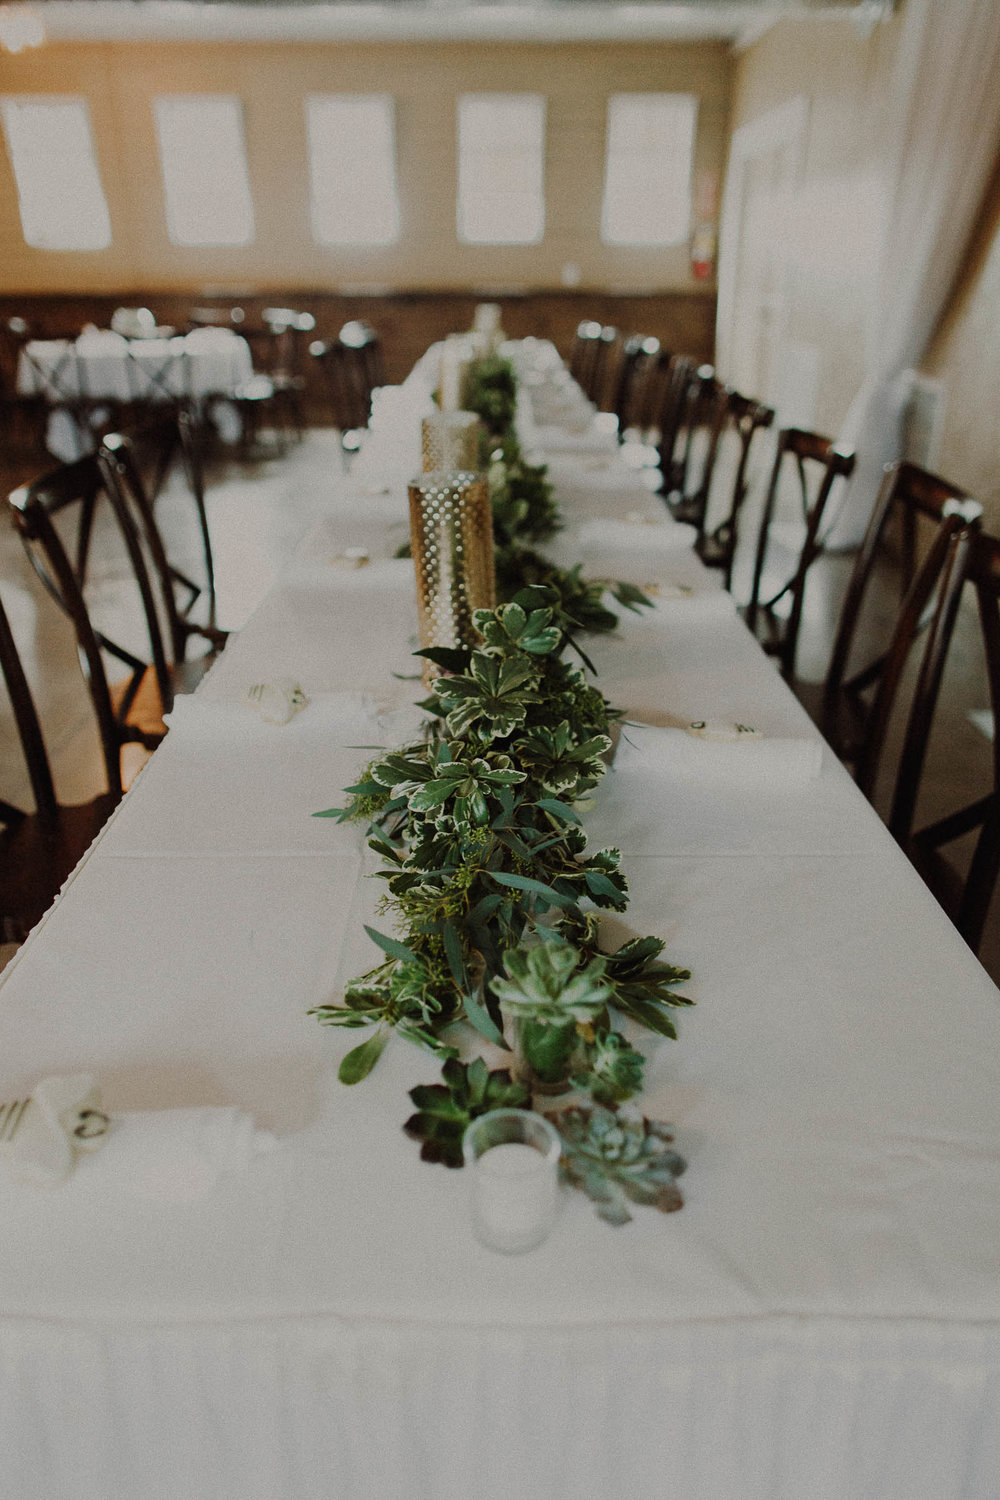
[[306, 95, 399, 245]]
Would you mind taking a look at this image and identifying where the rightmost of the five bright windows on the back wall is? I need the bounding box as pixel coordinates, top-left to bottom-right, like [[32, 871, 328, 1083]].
[[601, 95, 697, 245]]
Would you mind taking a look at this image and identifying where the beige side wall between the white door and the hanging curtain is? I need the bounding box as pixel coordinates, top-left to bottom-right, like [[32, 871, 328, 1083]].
[[733, 20, 900, 434]]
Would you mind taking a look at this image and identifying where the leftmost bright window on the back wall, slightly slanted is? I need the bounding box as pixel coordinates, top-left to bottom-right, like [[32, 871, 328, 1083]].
[[0, 95, 111, 251]]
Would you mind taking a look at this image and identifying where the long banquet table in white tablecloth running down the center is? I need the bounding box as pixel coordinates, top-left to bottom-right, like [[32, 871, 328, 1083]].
[[0, 343, 1000, 1500]]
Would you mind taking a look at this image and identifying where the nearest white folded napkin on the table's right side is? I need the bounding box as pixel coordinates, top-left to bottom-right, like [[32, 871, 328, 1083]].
[[615, 722, 823, 789]]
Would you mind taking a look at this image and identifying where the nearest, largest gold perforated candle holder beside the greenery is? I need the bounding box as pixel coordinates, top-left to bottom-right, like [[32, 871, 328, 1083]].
[[409, 470, 496, 686]]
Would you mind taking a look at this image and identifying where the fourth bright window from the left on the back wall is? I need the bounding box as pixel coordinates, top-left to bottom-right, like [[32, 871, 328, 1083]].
[[459, 95, 546, 245]]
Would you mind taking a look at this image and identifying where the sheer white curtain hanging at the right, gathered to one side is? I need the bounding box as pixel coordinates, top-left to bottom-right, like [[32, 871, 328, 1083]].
[[829, 0, 1000, 548]]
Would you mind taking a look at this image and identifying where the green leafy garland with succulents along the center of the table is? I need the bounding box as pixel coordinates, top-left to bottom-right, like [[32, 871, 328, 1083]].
[[310, 356, 691, 1224]]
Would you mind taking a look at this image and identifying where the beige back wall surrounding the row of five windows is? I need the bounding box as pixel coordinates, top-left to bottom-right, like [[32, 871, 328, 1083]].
[[0, 44, 732, 293]]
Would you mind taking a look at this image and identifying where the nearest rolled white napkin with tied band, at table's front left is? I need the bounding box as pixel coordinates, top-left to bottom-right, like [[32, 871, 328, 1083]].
[[0, 1073, 277, 1203]]
